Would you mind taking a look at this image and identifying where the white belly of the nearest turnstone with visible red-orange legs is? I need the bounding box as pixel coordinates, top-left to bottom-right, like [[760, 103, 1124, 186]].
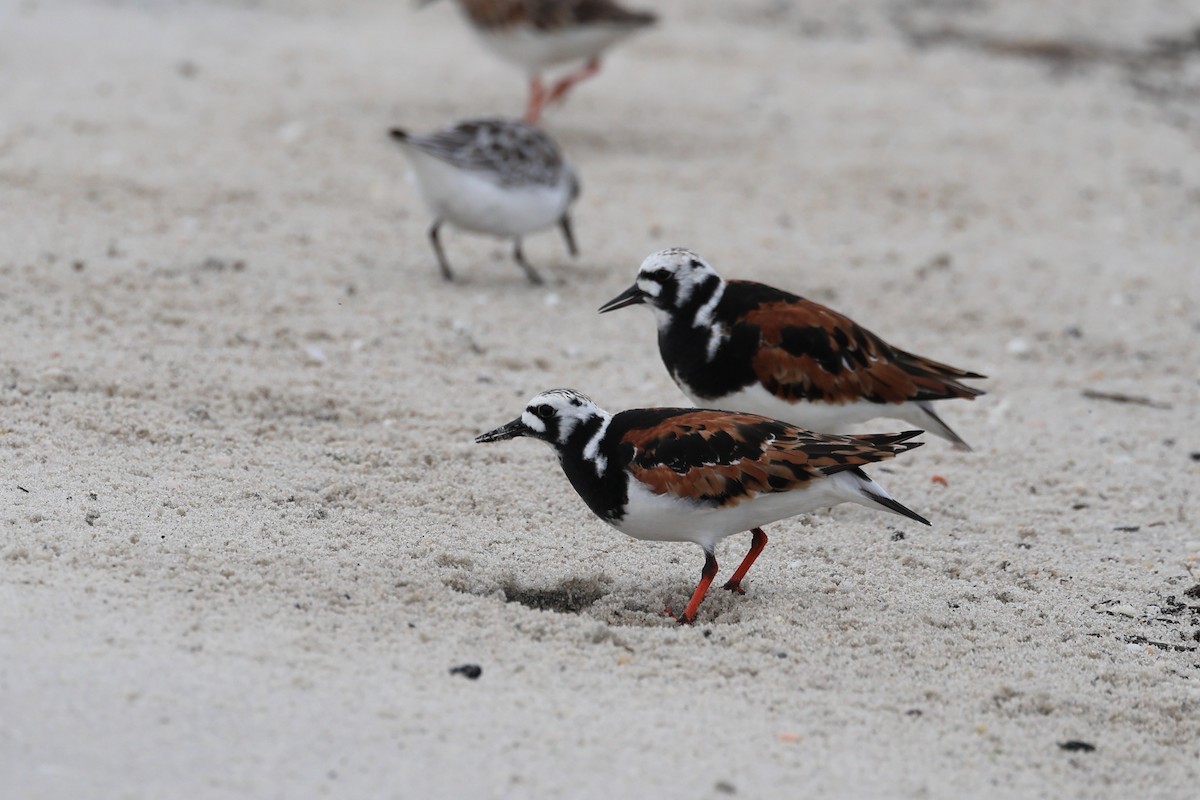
[[612, 473, 878, 551]]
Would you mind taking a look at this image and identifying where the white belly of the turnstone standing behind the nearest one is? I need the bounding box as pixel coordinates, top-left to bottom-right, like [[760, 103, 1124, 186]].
[[696, 384, 928, 433]]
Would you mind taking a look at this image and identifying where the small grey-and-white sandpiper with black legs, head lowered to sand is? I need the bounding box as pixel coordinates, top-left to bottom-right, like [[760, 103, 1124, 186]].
[[391, 116, 580, 283]]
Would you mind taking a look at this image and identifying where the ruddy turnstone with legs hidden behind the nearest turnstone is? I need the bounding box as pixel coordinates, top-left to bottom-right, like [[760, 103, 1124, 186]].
[[600, 247, 984, 450]]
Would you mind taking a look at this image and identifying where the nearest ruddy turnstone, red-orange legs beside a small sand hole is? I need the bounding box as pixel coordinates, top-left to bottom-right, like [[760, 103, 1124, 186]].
[[475, 389, 929, 622]]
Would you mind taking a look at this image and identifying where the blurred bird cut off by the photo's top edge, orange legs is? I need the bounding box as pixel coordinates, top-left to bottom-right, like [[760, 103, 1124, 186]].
[[421, 0, 658, 124]]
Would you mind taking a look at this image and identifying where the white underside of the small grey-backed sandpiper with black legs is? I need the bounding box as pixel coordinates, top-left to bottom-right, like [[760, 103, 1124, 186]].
[[404, 148, 571, 237]]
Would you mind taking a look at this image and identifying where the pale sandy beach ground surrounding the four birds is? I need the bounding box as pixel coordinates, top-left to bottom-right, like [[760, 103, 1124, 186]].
[[0, 0, 1200, 798]]
